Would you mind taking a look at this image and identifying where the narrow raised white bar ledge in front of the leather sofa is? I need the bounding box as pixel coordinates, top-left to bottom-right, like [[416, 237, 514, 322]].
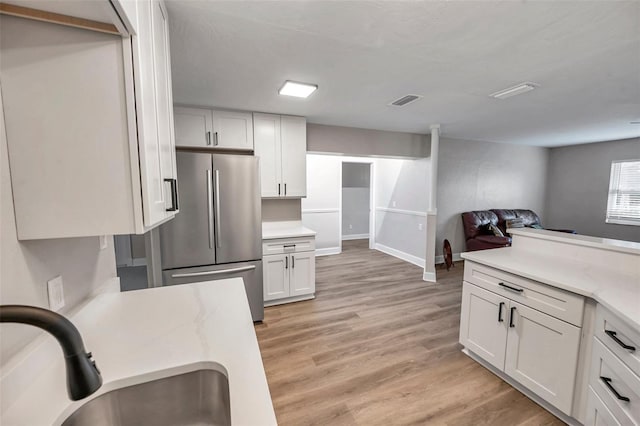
[[507, 228, 640, 255]]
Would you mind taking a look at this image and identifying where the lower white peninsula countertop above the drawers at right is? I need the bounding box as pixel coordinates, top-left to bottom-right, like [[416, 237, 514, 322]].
[[462, 247, 640, 329]]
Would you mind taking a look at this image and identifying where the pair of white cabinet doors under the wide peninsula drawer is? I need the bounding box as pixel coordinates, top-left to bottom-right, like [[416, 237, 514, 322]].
[[460, 282, 581, 416]]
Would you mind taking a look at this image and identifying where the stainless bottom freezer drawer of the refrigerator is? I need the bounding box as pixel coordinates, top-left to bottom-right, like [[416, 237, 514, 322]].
[[162, 260, 264, 321]]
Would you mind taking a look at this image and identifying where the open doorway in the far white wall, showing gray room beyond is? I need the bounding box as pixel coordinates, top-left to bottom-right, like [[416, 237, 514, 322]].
[[340, 161, 374, 248]]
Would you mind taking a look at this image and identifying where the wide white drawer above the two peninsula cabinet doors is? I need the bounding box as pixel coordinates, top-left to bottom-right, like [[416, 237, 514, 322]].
[[464, 261, 584, 327]]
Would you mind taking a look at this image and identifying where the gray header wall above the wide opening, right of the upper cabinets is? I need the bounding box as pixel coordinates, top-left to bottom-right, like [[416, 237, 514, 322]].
[[307, 123, 430, 158]]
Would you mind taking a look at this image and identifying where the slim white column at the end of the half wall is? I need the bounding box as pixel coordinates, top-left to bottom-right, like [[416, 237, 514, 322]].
[[422, 124, 440, 282]]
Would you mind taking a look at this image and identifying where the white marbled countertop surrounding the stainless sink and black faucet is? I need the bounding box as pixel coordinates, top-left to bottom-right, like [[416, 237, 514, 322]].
[[0, 278, 277, 426]]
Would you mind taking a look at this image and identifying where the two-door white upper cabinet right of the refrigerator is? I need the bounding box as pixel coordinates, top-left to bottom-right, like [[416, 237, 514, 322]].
[[253, 113, 307, 198]]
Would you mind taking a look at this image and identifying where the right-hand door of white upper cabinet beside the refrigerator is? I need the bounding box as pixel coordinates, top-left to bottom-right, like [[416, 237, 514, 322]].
[[280, 115, 307, 197]]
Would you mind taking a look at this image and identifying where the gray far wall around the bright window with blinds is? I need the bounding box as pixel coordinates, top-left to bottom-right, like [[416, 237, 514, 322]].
[[545, 138, 640, 242]]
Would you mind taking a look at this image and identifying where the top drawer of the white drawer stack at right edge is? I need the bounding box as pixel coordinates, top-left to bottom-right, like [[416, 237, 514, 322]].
[[595, 304, 640, 376]]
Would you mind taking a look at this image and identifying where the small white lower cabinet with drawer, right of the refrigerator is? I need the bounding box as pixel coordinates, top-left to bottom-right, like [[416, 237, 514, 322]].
[[262, 238, 316, 305]]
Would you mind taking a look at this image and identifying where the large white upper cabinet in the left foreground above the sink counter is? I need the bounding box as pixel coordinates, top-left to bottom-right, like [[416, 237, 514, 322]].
[[0, 0, 177, 240]]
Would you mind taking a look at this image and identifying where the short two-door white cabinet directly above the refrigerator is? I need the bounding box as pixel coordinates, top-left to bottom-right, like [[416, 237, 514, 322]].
[[174, 106, 253, 151]]
